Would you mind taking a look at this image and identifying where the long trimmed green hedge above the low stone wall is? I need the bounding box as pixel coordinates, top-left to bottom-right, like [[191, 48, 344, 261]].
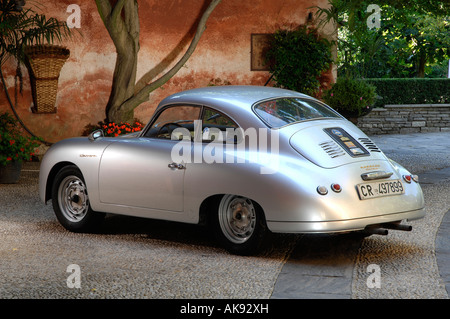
[[365, 78, 450, 107]]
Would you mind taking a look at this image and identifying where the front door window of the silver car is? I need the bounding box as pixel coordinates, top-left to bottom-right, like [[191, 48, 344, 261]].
[[144, 105, 201, 140]]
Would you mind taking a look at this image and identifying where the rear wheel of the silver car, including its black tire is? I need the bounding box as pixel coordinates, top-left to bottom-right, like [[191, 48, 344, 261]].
[[209, 195, 268, 255]]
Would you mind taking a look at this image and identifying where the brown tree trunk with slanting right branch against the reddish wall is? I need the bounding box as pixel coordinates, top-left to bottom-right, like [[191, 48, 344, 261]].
[[95, 0, 221, 122]]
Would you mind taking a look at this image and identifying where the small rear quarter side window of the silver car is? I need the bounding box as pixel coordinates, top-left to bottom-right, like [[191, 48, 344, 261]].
[[202, 107, 239, 142]]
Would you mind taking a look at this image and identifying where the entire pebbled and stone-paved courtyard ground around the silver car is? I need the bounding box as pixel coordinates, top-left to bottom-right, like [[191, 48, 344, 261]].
[[0, 133, 450, 299]]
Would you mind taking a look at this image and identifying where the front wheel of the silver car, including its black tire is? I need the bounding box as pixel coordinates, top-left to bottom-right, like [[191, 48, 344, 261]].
[[52, 166, 105, 233]]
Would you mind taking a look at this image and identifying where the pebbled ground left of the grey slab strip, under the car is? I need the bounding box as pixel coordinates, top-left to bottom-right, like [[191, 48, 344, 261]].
[[0, 165, 295, 299]]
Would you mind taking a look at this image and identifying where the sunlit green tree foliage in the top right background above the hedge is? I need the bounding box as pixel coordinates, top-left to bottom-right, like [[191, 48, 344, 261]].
[[316, 0, 450, 78]]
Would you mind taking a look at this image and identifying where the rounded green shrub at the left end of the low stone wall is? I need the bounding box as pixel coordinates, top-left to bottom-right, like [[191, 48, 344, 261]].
[[323, 77, 377, 118]]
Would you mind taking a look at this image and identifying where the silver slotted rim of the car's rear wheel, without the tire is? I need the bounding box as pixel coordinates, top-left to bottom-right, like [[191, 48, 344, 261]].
[[218, 195, 256, 244]]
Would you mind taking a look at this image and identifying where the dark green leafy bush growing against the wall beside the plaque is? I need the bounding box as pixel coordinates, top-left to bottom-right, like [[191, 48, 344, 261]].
[[266, 26, 332, 95]]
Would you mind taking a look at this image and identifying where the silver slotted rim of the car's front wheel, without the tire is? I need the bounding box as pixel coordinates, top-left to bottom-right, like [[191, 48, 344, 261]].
[[58, 176, 89, 222]]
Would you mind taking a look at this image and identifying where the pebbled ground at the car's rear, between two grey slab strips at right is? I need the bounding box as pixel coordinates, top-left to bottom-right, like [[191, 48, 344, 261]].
[[352, 133, 450, 299]]
